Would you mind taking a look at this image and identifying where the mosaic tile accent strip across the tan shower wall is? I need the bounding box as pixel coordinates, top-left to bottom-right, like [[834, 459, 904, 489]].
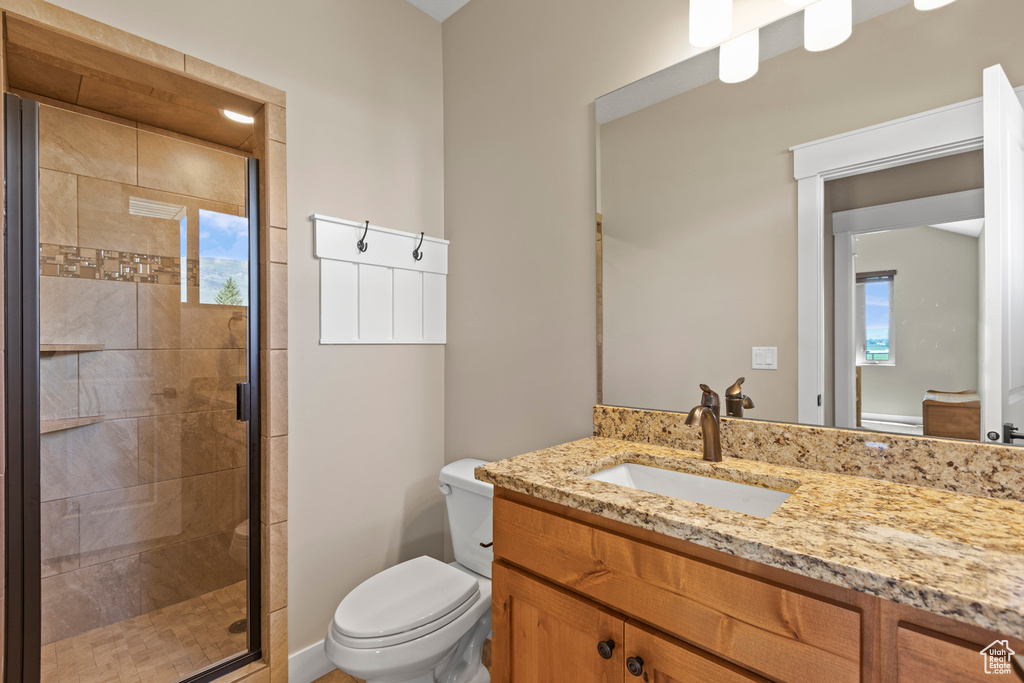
[[39, 244, 199, 287]]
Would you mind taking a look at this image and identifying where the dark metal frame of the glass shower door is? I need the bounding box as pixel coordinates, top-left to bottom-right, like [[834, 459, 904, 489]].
[[3, 93, 263, 683]]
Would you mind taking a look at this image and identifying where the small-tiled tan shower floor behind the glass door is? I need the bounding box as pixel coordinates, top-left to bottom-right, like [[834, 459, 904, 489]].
[[41, 582, 246, 683]]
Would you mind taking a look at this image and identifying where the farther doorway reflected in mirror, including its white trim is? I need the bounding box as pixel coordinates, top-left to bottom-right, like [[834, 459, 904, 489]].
[[833, 189, 984, 440]]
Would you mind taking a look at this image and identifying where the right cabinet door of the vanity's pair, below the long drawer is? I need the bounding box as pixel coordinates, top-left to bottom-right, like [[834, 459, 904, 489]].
[[618, 622, 766, 683]]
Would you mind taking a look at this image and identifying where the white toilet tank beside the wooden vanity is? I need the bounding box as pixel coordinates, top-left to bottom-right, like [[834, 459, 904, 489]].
[[438, 459, 495, 578]]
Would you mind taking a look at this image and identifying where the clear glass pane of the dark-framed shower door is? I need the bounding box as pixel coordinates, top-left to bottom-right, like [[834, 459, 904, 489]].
[[24, 98, 255, 683]]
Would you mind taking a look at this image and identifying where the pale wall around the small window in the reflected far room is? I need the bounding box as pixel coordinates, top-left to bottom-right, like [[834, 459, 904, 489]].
[[856, 227, 979, 418]]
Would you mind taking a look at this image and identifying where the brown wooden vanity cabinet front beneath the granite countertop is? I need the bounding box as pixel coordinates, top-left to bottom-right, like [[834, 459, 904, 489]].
[[493, 488, 1024, 683]]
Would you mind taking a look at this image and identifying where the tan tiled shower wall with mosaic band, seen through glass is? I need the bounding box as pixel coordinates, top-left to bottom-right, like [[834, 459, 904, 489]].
[[40, 106, 247, 644]]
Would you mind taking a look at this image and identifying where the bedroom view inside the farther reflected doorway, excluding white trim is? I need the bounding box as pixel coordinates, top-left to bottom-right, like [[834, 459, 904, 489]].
[[854, 221, 981, 438]]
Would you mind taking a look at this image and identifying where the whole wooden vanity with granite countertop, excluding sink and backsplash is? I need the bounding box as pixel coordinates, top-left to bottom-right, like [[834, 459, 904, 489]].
[[476, 419, 1024, 683]]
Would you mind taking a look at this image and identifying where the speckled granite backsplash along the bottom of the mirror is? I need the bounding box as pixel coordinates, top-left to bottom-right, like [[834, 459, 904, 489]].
[[594, 405, 1024, 501]]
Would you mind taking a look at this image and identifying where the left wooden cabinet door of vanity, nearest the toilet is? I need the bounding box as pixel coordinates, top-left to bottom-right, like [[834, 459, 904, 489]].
[[492, 563, 626, 683]]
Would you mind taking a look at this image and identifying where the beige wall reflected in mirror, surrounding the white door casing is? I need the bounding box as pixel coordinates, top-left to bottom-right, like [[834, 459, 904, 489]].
[[601, 0, 1024, 421]]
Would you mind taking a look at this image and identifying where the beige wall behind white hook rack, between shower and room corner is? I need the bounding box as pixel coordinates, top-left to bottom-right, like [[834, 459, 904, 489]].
[[47, 0, 444, 652]]
